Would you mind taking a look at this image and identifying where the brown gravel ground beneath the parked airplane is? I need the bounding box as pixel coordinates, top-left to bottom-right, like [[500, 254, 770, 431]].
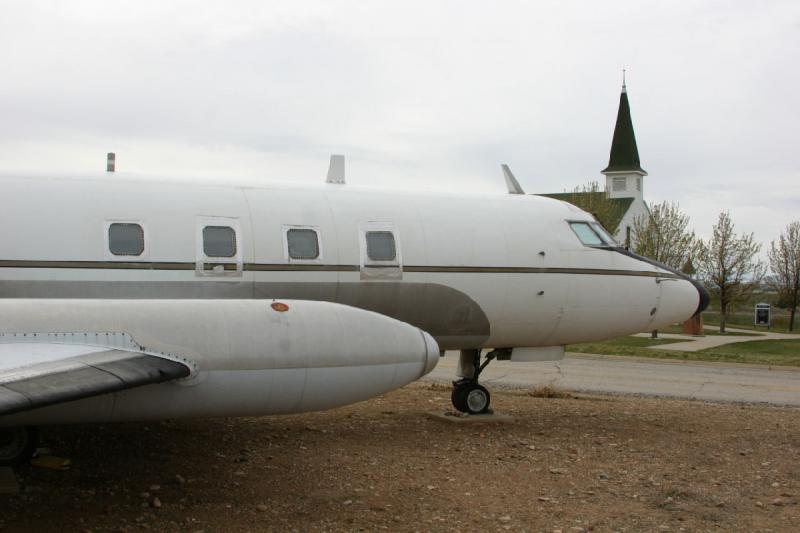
[[0, 383, 800, 533]]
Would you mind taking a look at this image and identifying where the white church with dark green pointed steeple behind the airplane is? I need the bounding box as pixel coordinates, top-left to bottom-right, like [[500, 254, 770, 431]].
[[542, 83, 650, 247]]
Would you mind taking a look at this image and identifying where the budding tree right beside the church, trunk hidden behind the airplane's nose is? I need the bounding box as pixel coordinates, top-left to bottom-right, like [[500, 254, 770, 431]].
[[633, 201, 700, 269]]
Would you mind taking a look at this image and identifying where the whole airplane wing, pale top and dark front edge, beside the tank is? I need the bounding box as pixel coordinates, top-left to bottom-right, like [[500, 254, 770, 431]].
[[0, 339, 191, 416]]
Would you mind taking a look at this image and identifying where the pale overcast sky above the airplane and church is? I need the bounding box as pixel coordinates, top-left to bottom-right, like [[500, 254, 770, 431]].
[[0, 0, 800, 249]]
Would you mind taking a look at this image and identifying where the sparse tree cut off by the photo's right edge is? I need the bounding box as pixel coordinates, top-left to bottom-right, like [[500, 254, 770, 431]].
[[767, 222, 800, 331]]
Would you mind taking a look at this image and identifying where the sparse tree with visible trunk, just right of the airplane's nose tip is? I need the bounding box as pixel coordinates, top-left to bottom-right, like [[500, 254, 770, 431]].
[[700, 211, 764, 333]]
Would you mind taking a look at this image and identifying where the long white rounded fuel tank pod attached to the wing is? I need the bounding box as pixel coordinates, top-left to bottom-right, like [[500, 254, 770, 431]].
[[0, 299, 439, 425]]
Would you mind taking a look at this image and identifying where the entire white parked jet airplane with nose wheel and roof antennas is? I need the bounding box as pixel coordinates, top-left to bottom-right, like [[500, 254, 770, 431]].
[[0, 156, 708, 464]]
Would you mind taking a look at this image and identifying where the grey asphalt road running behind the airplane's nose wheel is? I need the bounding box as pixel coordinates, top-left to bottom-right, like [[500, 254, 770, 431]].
[[425, 352, 800, 406]]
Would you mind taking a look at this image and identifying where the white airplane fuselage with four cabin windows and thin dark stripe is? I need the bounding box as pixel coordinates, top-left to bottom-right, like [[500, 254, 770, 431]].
[[0, 174, 699, 349]]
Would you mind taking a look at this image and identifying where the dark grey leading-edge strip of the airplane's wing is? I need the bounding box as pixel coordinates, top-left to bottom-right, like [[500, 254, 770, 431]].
[[0, 344, 191, 415]]
